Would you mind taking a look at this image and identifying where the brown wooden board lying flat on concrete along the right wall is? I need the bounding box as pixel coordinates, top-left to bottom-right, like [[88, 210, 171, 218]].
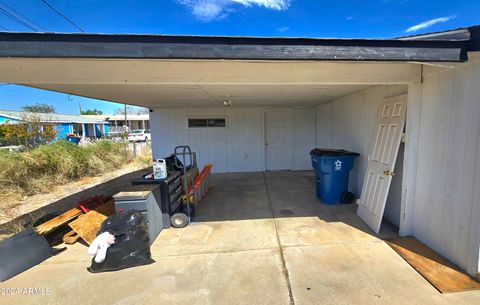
[[385, 237, 480, 293]]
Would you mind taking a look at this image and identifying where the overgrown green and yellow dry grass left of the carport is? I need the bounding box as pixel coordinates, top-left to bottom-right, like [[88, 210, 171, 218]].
[[0, 140, 132, 197]]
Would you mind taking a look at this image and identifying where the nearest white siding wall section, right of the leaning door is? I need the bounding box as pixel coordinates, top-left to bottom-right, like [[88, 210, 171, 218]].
[[414, 60, 480, 276]]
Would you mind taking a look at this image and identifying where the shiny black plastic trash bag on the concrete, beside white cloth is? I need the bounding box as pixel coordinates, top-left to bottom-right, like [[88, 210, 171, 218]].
[[88, 210, 155, 273]]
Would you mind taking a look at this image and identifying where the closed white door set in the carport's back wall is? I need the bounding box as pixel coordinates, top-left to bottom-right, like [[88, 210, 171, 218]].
[[265, 111, 292, 170]]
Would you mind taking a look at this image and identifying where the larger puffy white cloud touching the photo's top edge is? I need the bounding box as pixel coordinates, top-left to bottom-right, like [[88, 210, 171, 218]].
[[177, 0, 290, 21]]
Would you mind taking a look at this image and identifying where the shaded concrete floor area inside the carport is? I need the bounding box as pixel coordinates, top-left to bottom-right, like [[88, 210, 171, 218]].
[[194, 171, 398, 238]]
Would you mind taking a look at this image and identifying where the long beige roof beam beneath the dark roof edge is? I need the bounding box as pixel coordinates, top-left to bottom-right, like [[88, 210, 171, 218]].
[[0, 58, 421, 87]]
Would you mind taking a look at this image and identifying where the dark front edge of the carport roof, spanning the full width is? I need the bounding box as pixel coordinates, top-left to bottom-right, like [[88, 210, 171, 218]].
[[0, 26, 480, 62]]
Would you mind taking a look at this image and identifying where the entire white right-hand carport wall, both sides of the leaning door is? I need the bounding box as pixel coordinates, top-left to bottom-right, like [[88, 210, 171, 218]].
[[316, 55, 480, 276]]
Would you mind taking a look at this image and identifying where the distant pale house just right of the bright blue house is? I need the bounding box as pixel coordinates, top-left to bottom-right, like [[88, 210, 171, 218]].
[[82, 114, 150, 136]]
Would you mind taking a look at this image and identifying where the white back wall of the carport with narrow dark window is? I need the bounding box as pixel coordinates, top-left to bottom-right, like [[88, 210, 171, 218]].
[[150, 107, 316, 172]]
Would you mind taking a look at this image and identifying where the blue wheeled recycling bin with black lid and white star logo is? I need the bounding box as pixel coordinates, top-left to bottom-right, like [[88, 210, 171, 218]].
[[310, 148, 360, 204]]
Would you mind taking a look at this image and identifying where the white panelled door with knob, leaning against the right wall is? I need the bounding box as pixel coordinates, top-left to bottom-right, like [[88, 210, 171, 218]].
[[357, 95, 407, 233]]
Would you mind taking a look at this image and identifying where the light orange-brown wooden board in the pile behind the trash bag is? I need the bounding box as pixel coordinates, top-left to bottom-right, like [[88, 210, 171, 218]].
[[68, 200, 115, 245]]
